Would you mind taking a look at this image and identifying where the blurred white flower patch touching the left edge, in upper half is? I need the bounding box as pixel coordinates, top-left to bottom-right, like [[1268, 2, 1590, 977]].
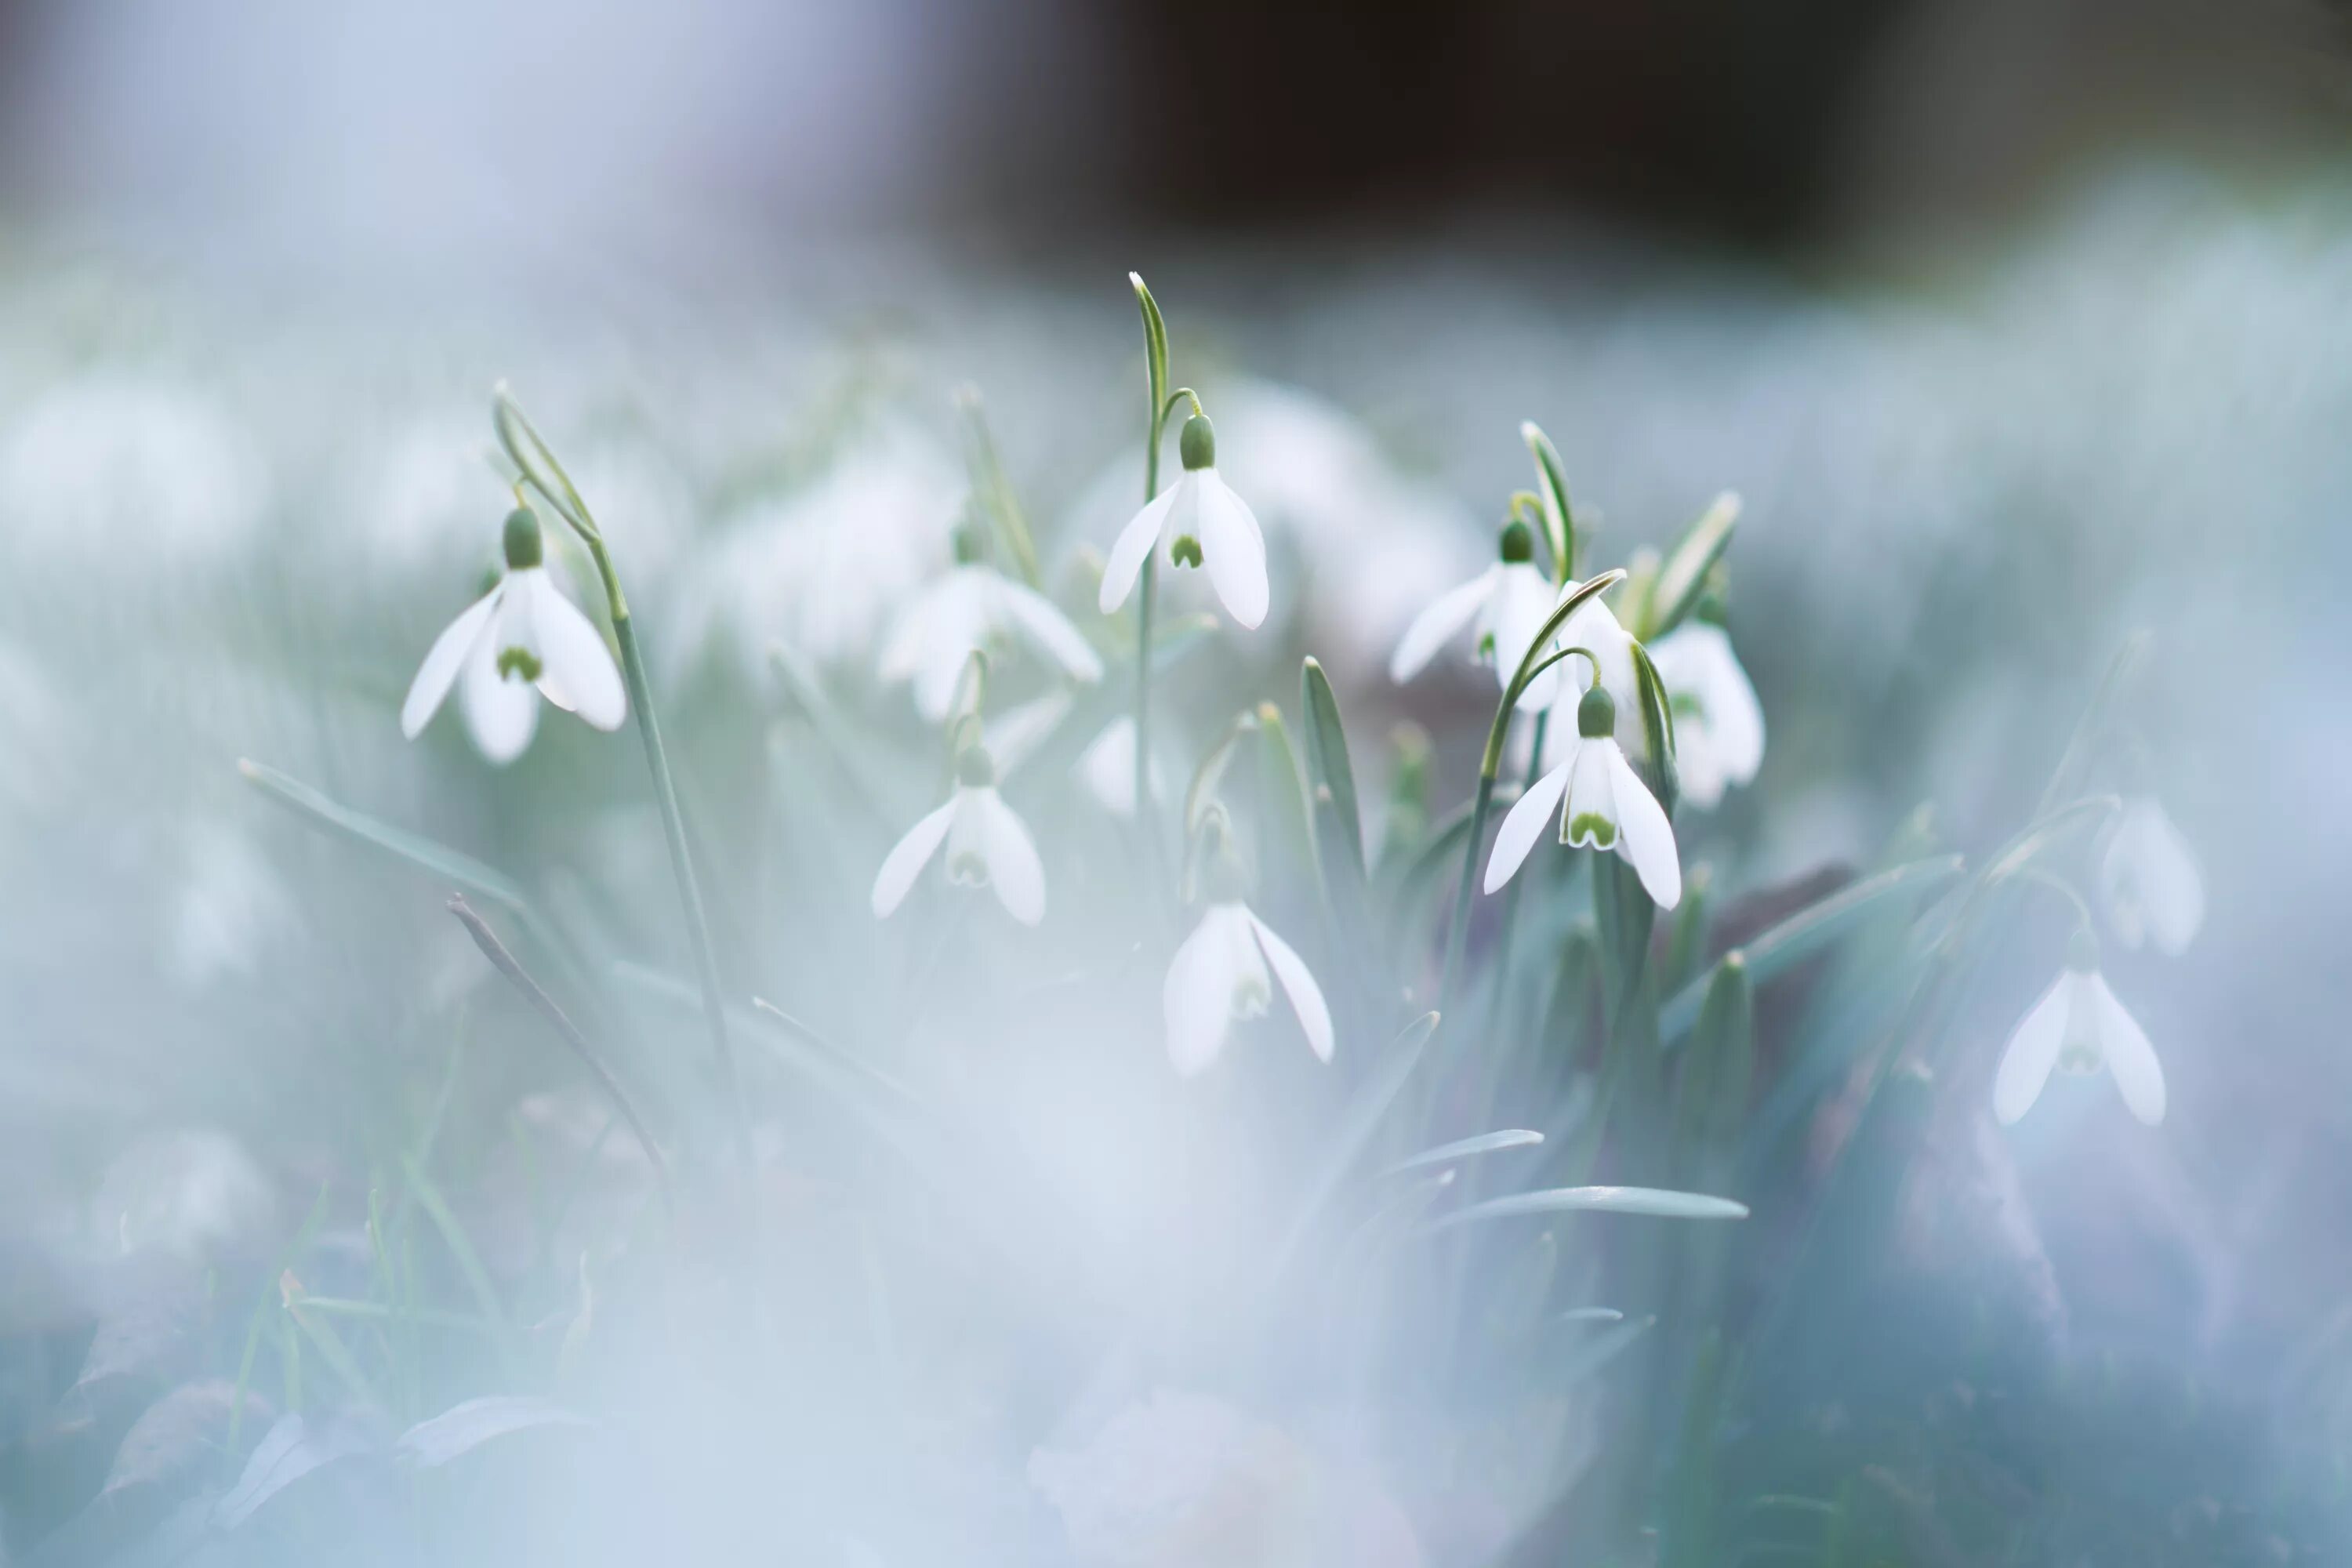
[[0, 372, 270, 564]]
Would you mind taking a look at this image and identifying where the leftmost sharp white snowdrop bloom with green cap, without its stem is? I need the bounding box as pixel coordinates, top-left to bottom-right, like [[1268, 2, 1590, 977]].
[[400, 506, 628, 767]]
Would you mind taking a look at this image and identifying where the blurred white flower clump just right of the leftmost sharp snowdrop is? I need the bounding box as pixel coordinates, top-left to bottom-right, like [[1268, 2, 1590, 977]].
[[663, 423, 967, 675]]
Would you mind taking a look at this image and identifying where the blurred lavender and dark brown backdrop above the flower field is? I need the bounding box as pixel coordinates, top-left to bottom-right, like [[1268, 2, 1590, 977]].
[[0, 0, 2352, 267]]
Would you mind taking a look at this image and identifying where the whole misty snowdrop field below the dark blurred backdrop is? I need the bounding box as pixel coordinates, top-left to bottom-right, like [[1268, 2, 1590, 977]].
[[0, 162, 2352, 1566]]
